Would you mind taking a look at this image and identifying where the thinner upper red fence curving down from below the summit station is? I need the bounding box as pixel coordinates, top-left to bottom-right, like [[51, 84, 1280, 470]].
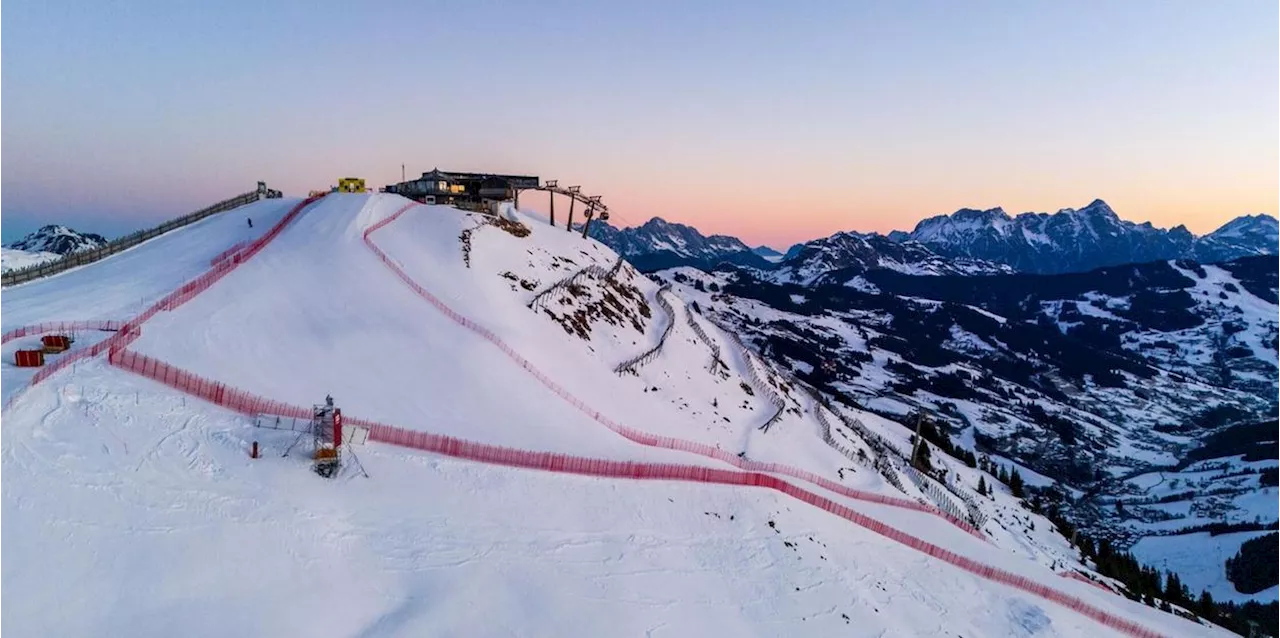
[[364, 202, 987, 541]]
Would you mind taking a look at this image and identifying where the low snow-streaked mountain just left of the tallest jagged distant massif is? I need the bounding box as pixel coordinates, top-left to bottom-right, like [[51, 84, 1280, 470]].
[[765, 232, 1012, 284]]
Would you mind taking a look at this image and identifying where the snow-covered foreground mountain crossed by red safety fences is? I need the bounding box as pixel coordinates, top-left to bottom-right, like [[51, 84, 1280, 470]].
[[0, 193, 1225, 637]]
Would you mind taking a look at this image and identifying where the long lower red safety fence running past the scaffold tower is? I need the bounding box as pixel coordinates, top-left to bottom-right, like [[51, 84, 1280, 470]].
[[109, 350, 1160, 638]]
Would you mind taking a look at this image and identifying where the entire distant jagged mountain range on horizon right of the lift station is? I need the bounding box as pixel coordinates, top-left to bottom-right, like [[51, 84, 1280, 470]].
[[591, 200, 1280, 278]]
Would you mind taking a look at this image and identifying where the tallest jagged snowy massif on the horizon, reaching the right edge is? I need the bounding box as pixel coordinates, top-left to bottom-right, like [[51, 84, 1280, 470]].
[[906, 200, 1280, 274]]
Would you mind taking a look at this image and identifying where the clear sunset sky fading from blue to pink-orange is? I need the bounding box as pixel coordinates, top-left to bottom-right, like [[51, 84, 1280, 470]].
[[0, 0, 1280, 247]]
